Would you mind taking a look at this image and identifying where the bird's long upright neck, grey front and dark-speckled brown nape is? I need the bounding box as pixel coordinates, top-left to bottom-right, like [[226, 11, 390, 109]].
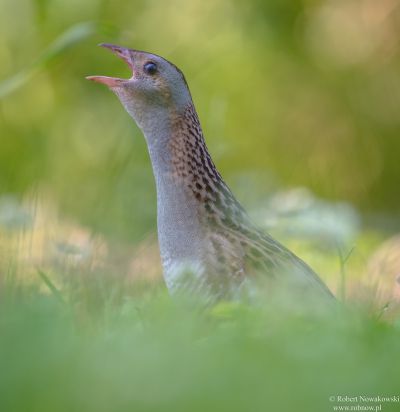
[[142, 104, 245, 282]]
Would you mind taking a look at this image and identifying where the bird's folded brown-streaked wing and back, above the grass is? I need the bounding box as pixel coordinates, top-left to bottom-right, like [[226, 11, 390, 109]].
[[203, 181, 333, 297]]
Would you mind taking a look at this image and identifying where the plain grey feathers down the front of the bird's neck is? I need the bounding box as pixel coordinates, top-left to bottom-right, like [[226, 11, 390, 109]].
[[138, 104, 209, 288]]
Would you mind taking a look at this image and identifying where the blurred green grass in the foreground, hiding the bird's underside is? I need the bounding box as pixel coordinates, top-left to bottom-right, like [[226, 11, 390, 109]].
[[0, 273, 400, 412]]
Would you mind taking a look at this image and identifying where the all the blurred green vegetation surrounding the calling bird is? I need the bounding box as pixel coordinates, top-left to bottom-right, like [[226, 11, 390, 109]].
[[0, 0, 400, 412]]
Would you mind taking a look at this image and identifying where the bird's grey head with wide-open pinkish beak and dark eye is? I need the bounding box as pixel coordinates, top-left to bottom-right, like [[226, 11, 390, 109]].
[[87, 44, 191, 129]]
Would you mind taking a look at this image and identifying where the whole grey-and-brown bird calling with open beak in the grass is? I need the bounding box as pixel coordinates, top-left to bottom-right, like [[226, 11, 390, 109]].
[[86, 43, 334, 302]]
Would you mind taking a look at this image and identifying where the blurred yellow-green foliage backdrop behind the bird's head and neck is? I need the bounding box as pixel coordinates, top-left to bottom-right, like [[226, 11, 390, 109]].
[[0, 0, 400, 241]]
